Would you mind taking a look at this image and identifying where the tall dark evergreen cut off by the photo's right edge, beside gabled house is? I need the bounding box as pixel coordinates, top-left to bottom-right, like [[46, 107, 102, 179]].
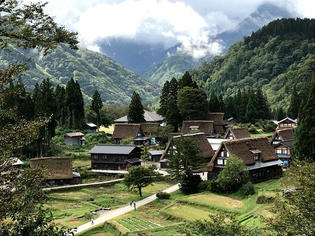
[[293, 79, 315, 161]]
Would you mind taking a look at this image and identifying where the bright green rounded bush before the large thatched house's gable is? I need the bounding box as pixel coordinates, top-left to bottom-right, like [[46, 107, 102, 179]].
[[216, 156, 248, 193]]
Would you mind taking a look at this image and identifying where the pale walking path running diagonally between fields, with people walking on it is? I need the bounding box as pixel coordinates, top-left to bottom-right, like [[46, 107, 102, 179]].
[[75, 184, 179, 234]]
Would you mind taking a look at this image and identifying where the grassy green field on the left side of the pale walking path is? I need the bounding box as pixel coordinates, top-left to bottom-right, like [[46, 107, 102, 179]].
[[46, 182, 171, 227]]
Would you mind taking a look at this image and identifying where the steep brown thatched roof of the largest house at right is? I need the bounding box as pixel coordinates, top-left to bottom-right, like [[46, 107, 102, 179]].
[[206, 137, 279, 171]]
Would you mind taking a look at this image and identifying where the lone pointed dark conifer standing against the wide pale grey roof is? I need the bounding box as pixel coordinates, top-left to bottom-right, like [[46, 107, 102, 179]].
[[127, 92, 145, 123]]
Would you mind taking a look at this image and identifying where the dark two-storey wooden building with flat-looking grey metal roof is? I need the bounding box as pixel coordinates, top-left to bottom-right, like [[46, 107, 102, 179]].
[[89, 145, 141, 170]]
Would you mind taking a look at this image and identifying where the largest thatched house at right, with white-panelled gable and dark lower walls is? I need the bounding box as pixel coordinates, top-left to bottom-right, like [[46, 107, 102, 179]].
[[205, 137, 282, 182]]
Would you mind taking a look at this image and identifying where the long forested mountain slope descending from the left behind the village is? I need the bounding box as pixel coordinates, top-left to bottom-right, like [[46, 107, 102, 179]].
[[0, 45, 159, 104]]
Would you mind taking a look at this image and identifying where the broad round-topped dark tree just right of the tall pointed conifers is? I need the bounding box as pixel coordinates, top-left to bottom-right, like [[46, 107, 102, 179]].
[[178, 87, 208, 120]]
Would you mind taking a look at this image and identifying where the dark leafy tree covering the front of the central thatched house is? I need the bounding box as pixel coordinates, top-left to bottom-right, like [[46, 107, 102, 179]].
[[167, 137, 203, 181]]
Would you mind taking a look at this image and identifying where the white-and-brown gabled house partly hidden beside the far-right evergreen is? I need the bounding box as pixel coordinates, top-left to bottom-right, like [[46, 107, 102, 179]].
[[271, 128, 294, 167]]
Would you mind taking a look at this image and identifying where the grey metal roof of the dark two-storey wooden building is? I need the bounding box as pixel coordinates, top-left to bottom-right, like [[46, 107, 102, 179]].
[[89, 145, 136, 155]]
